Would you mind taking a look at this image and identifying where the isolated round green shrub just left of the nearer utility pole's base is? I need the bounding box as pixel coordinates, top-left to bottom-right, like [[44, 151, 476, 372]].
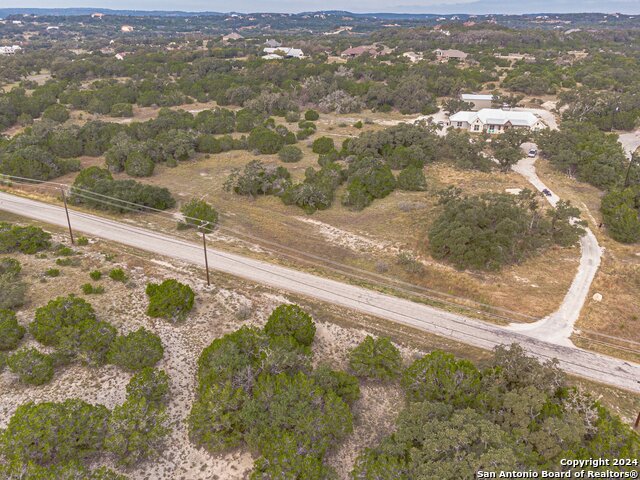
[[146, 279, 195, 322]]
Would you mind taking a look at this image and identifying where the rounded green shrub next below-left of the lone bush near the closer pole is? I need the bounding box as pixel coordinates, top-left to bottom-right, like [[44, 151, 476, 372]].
[[107, 327, 164, 371]]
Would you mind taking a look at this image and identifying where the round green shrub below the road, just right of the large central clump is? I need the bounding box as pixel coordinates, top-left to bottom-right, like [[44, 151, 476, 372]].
[[349, 335, 402, 380]]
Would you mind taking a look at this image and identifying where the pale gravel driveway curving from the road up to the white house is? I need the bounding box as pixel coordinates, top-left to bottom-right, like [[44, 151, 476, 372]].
[[508, 143, 603, 347]]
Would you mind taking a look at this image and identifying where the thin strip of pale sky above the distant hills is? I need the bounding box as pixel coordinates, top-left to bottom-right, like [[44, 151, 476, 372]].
[[7, 0, 640, 14]]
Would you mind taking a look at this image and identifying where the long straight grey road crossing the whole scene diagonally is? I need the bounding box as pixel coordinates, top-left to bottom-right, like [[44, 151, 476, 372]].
[[0, 192, 640, 393]]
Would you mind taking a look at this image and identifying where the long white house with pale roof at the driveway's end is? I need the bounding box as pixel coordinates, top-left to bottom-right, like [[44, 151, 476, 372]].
[[449, 108, 547, 133]]
